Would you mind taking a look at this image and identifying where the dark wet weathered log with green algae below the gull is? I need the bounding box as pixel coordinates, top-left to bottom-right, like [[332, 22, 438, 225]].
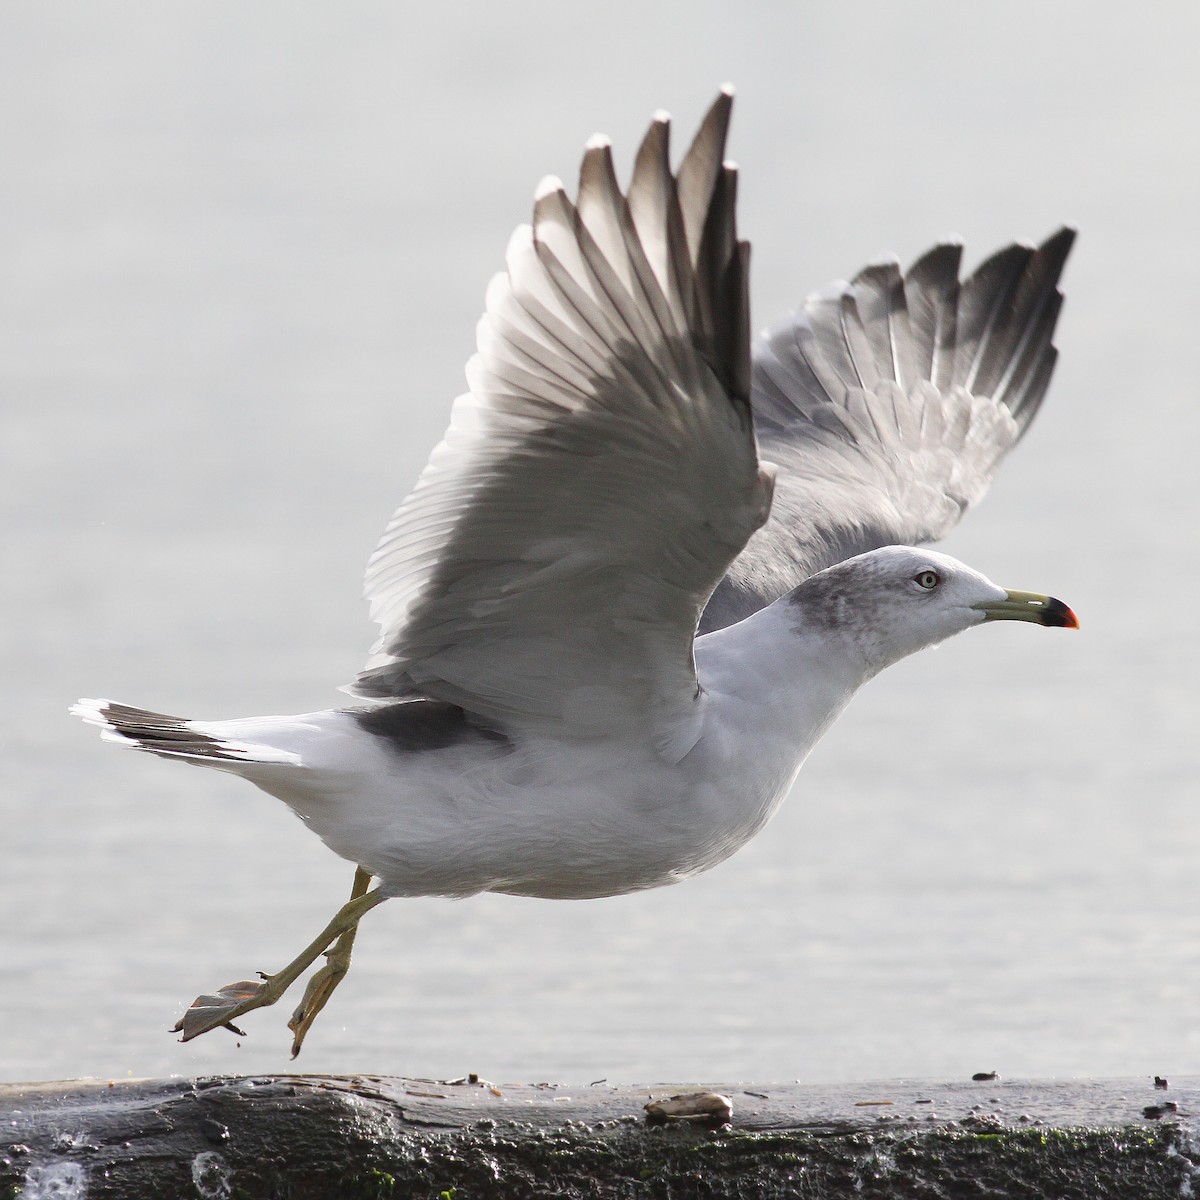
[[0, 1075, 1200, 1200]]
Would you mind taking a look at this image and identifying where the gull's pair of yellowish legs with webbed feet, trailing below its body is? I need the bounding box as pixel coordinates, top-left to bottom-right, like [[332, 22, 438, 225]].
[[173, 866, 386, 1057]]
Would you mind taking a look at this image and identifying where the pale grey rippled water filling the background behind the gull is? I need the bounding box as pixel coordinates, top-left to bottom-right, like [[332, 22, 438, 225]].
[[0, 0, 1200, 1081]]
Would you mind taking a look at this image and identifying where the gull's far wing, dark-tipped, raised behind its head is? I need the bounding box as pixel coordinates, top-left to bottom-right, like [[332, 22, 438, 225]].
[[701, 229, 1074, 632]]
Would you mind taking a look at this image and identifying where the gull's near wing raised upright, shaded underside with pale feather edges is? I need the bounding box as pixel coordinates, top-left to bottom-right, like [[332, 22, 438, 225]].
[[350, 91, 770, 737]]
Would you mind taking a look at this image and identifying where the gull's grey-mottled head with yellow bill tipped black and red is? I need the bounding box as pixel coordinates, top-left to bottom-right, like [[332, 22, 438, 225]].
[[790, 546, 1079, 671]]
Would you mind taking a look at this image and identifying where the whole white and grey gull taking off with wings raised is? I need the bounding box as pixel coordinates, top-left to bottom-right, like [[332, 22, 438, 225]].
[[72, 88, 1078, 1057]]
